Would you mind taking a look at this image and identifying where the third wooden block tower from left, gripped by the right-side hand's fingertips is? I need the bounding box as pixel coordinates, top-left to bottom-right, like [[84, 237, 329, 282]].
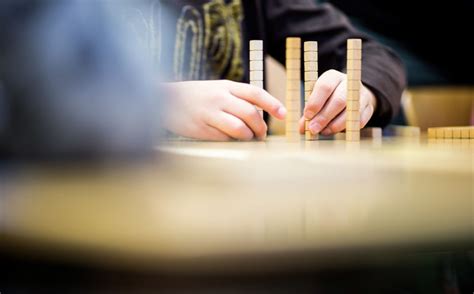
[[303, 41, 319, 141]]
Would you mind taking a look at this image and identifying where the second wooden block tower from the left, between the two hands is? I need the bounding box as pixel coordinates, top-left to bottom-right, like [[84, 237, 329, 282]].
[[285, 37, 301, 140]]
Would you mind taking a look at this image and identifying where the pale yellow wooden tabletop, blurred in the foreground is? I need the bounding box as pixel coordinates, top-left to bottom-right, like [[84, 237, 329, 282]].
[[0, 137, 474, 270]]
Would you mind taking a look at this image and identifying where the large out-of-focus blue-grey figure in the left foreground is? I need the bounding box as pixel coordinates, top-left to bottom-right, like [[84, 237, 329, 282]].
[[0, 0, 160, 159]]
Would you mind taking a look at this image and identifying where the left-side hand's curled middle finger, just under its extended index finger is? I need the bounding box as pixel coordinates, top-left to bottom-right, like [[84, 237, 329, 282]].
[[223, 95, 267, 139]]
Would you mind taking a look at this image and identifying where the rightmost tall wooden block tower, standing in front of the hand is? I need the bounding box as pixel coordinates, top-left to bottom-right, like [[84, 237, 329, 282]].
[[346, 39, 362, 141]]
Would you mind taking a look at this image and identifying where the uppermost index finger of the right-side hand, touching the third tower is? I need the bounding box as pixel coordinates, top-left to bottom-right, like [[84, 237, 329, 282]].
[[304, 70, 345, 119]]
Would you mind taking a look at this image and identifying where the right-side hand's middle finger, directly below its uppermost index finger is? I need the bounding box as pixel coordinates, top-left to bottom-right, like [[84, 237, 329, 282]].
[[309, 81, 347, 134]]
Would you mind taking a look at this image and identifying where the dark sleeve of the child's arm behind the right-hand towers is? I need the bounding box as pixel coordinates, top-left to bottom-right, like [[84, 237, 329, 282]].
[[262, 0, 406, 127]]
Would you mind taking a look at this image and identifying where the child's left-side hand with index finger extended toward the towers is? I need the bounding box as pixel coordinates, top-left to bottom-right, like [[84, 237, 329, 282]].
[[165, 80, 286, 141]]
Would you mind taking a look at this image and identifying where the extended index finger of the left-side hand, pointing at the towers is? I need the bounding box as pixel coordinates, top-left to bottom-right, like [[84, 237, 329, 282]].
[[225, 81, 286, 119]]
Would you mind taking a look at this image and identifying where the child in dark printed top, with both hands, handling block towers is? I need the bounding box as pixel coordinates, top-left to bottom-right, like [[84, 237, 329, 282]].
[[132, 0, 405, 140]]
